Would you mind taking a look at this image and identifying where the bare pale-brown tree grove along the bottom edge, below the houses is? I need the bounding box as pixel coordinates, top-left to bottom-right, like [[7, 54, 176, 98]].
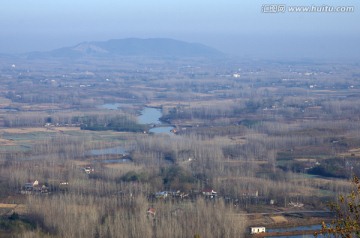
[[24, 194, 246, 238]]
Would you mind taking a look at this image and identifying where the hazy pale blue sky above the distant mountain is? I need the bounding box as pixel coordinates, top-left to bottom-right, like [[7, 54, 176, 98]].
[[0, 0, 360, 57]]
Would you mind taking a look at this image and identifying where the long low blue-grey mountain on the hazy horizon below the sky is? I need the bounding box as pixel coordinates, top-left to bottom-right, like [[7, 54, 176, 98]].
[[29, 38, 223, 58]]
